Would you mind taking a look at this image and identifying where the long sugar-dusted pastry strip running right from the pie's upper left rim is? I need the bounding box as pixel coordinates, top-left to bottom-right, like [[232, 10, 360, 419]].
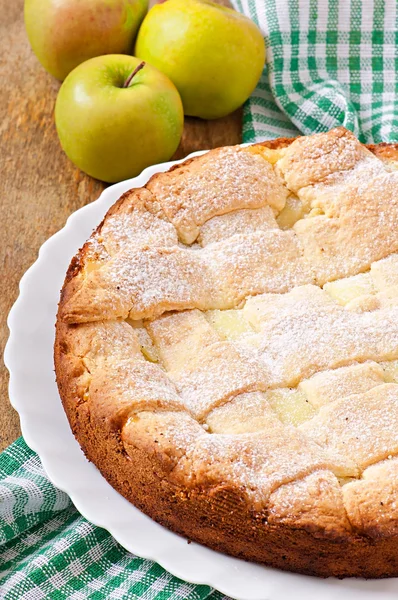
[[59, 229, 313, 323]]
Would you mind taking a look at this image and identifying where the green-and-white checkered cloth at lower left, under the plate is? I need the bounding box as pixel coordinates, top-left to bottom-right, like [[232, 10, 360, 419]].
[[0, 438, 228, 600]]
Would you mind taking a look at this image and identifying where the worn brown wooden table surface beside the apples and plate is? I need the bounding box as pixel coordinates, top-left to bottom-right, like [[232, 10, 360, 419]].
[[0, 0, 241, 450]]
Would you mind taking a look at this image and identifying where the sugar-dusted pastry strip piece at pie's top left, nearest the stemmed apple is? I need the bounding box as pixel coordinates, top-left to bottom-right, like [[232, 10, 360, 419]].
[[147, 147, 288, 244]]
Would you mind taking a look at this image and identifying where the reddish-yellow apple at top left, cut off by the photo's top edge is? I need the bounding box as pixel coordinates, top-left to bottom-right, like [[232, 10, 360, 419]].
[[25, 0, 148, 81]]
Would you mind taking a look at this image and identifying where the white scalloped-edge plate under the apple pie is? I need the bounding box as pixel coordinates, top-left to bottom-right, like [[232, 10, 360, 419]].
[[4, 152, 398, 600]]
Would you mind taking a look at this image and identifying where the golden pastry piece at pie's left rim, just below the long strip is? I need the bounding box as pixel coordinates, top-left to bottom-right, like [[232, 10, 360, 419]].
[[64, 321, 185, 431]]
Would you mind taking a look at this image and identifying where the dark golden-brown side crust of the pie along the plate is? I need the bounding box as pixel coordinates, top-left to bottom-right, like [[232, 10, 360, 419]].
[[54, 140, 398, 578]]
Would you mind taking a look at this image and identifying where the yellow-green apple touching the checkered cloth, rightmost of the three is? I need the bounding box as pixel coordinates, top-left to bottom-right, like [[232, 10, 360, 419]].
[[135, 0, 265, 119]]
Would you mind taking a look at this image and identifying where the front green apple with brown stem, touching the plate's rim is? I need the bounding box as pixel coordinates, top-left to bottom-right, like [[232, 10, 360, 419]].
[[55, 54, 184, 182]]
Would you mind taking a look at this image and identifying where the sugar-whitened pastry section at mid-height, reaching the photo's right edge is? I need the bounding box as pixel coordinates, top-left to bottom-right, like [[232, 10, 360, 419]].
[[244, 286, 398, 386]]
